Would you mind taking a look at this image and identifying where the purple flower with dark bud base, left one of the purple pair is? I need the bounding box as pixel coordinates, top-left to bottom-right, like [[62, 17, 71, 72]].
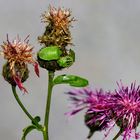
[[68, 88, 113, 138]]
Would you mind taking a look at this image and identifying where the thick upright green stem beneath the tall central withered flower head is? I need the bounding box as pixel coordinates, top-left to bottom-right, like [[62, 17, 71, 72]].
[[44, 71, 54, 140]]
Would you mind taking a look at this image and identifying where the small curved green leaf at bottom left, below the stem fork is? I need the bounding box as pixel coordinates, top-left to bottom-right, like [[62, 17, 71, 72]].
[[21, 125, 36, 140]]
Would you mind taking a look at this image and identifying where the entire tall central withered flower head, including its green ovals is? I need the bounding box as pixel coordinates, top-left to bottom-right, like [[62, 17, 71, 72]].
[[37, 6, 75, 71]]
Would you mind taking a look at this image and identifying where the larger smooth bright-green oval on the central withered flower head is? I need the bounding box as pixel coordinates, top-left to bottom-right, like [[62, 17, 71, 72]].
[[38, 46, 62, 61]]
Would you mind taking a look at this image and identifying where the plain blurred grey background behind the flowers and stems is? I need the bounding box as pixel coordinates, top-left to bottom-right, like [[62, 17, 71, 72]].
[[0, 0, 140, 140]]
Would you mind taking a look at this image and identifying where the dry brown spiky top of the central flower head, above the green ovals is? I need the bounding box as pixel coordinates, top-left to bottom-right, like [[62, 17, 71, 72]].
[[38, 6, 75, 48]]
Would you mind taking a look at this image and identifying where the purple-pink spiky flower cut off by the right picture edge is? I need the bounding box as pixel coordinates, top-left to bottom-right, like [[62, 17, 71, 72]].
[[112, 83, 140, 140]]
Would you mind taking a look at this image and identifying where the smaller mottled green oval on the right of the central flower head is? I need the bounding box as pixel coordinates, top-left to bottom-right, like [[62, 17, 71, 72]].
[[57, 56, 74, 68]]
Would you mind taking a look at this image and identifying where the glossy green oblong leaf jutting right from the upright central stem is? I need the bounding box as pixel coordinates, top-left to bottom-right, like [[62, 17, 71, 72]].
[[54, 75, 88, 87]]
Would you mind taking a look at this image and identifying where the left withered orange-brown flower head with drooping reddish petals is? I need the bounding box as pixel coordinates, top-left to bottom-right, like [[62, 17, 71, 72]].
[[1, 35, 39, 92]]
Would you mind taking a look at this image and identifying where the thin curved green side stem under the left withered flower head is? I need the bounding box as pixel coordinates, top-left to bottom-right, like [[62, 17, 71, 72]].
[[12, 86, 41, 128]]
